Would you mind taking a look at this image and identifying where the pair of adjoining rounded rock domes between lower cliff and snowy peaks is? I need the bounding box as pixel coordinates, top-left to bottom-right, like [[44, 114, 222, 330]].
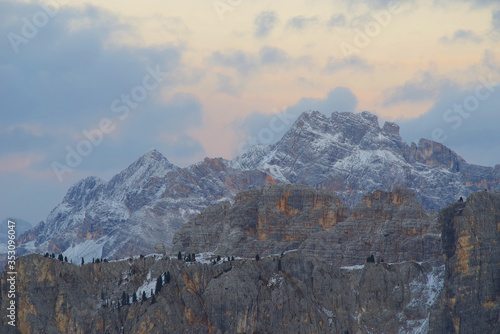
[[173, 185, 441, 266]]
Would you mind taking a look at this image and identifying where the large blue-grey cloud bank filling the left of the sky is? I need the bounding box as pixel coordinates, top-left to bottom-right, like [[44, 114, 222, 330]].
[[0, 1, 204, 184]]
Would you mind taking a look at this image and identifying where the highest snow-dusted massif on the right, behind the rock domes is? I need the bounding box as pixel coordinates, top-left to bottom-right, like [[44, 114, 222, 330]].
[[232, 111, 500, 209]]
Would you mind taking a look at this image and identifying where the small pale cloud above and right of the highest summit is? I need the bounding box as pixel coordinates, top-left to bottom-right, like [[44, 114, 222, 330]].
[[384, 69, 453, 107]]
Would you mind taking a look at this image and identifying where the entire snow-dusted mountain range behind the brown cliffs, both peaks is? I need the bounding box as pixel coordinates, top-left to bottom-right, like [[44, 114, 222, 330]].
[[19, 111, 500, 261]]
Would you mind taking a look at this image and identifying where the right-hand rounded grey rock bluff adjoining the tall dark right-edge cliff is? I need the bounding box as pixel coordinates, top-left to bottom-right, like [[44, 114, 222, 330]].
[[300, 188, 442, 266]]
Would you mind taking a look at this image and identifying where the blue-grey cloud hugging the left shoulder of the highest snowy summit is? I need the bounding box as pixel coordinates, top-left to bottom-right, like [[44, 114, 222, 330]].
[[233, 87, 358, 153]]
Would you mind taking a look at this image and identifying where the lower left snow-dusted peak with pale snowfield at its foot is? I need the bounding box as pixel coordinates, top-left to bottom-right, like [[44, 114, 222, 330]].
[[19, 150, 266, 263]]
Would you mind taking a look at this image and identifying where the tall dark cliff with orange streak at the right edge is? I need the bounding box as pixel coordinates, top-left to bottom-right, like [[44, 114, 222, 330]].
[[431, 191, 500, 333]]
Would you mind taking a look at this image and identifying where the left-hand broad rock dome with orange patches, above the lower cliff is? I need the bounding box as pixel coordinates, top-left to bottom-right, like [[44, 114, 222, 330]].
[[173, 184, 349, 257]]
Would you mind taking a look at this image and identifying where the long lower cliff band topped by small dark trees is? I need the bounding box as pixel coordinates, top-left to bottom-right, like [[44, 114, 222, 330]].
[[1, 252, 442, 334]]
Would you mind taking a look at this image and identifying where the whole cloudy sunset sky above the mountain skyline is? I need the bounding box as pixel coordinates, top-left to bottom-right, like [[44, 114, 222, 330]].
[[0, 0, 500, 224]]
